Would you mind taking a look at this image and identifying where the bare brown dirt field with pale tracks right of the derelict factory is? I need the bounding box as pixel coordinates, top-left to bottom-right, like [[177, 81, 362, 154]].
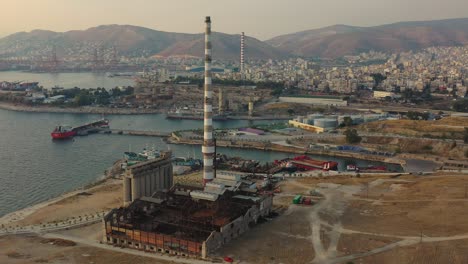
[[219, 173, 468, 264]]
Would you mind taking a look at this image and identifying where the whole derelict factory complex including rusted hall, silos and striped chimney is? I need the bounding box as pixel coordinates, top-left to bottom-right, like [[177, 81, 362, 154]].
[[100, 17, 273, 259]]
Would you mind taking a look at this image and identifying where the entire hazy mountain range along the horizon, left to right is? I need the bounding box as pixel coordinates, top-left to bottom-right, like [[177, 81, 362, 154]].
[[0, 18, 468, 61]]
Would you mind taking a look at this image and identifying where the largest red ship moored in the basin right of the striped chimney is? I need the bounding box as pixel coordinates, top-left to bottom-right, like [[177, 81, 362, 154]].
[[275, 156, 338, 171]]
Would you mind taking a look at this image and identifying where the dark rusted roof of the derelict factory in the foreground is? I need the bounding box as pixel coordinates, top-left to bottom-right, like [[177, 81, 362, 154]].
[[105, 186, 261, 242]]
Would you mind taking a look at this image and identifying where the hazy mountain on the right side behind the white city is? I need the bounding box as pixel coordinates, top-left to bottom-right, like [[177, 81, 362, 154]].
[[266, 18, 468, 58]]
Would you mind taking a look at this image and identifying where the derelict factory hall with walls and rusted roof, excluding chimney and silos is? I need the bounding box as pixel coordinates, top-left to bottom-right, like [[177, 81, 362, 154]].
[[104, 174, 273, 258]]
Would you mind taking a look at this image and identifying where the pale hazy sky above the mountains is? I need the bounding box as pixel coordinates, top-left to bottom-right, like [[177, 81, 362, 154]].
[[0, 0, 468, 40]]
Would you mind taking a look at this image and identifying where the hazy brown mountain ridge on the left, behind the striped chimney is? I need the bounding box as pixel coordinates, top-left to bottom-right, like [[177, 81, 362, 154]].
[[0, 24, 288, 60]]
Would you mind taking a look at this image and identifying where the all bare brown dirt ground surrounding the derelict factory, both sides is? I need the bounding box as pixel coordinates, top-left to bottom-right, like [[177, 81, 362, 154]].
[[4, 173, 468, 264]]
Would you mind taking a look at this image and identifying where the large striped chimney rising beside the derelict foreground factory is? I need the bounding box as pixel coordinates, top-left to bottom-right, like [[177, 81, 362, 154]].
[[202, 16, 215, 183]]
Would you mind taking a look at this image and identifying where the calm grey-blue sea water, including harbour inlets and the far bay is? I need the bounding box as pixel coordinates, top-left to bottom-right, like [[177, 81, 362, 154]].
[[0, 72, 402, 216]]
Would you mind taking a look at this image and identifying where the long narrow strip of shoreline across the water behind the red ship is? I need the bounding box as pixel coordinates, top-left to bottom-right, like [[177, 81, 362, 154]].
[[0, 102, 165, 115]]
